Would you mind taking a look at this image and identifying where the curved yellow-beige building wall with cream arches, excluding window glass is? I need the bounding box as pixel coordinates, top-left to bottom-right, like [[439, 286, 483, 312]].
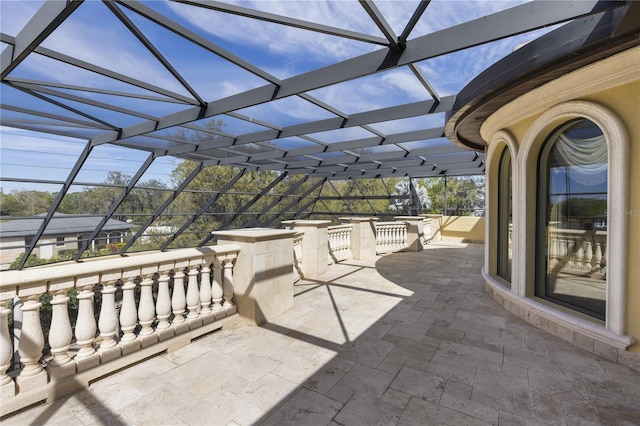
[[481, 47, 640, 369]]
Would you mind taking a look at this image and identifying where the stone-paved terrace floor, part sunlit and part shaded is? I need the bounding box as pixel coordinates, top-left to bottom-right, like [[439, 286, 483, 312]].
[[2, 243, 640, 426]]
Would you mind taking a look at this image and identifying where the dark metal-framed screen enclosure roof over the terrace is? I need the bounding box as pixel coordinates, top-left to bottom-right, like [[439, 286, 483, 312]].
[[0, 0, 625, 268]]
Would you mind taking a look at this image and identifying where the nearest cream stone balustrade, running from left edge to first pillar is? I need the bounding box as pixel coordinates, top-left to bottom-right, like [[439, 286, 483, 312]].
[[0, 244, 239, 415]]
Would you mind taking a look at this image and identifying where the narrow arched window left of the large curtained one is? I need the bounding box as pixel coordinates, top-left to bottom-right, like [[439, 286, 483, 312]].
[[497, 146, 513, 284]]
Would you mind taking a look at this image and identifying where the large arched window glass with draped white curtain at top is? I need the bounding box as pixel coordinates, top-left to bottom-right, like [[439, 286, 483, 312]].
[[535, 118, 609, 320]]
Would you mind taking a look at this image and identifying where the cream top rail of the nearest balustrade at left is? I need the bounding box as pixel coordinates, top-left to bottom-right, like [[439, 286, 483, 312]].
[[0, 244, 240, 293]]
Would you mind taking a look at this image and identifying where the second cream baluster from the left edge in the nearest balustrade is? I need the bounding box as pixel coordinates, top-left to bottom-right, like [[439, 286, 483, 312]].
[[17, 292, 47, 392]]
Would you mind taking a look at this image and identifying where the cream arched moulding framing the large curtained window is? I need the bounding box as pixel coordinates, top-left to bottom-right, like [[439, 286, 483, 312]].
[[514, 100, 629, 340]]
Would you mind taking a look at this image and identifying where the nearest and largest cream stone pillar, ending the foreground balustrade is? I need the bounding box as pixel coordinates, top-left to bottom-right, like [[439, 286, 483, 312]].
[[213, 228, 295, 325]]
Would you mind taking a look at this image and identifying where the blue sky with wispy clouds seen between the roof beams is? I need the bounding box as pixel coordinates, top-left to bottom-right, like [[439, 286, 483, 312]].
[[0, 0, 542, 192]]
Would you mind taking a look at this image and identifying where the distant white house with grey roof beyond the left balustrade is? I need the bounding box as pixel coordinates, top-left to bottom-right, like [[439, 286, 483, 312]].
[[0, 213, 132, 269]]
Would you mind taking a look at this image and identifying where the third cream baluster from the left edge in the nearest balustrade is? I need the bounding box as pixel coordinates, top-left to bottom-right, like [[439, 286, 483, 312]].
[[49, 288, 75, 377]]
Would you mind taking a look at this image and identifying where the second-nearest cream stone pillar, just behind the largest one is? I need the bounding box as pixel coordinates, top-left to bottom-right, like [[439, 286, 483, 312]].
[[282, 220, 331, 279]]
